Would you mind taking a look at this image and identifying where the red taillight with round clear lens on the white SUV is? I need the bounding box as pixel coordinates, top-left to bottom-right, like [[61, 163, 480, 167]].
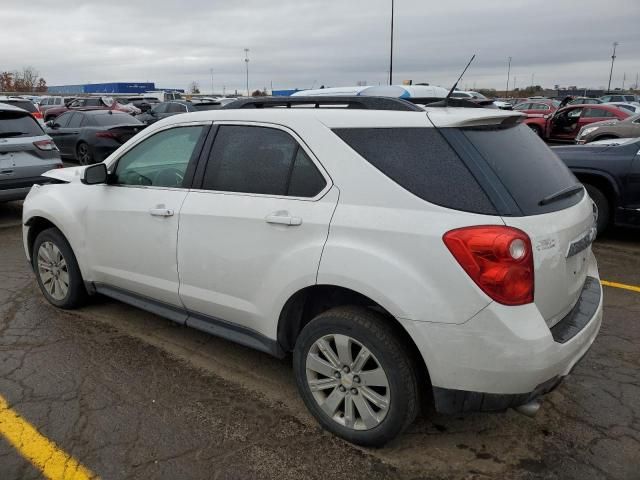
[[443, 226, 534, 305]]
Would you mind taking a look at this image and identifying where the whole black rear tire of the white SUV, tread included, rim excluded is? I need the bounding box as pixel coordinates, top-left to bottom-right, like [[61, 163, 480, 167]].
[[293, 307, 419, 447]]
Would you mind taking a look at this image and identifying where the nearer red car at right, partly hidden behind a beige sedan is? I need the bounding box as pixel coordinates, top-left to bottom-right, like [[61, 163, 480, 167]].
[[524, 105, 631, 142]]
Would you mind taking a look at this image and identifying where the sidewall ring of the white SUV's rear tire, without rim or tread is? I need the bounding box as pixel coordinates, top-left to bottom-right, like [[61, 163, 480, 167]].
[[293, 315, 413, 447]]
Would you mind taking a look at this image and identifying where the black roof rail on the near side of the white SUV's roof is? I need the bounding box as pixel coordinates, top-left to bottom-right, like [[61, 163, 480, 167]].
[[222, 95, 424, 112]]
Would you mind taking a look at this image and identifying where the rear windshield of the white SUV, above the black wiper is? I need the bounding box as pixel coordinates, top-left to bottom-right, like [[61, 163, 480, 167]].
[[442, 125, 584, 215]]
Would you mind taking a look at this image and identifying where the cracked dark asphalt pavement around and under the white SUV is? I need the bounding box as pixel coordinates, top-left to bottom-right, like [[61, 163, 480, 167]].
[[0, 203, 640, 480]]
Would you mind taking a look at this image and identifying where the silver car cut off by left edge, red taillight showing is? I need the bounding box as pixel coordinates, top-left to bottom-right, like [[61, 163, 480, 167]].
[[0, 103, 63, 202]]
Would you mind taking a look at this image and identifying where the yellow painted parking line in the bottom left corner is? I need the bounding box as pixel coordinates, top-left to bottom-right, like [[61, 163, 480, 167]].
[[0, 395, 97, 480]]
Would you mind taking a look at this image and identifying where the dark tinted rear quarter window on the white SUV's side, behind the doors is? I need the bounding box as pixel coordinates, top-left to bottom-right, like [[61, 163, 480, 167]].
[[333, 127, 497, 215]]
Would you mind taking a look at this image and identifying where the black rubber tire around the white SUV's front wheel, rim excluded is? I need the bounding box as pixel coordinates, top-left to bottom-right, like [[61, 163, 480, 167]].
[[31, 228, 87, 309]]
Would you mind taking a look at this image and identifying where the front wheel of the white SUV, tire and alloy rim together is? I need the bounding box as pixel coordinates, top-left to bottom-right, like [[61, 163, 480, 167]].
[[31, 228, 87, 308]]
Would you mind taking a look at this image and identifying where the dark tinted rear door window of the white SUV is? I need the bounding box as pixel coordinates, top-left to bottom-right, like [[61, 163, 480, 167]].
[[202, 125, 325, 197]]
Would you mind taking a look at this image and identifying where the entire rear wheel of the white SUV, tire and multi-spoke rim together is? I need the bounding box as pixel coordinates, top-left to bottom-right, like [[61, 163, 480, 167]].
[[294, 307, 418, 446]]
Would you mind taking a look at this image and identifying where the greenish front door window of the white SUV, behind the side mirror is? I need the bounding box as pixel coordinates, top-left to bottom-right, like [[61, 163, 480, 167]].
[[113, 125, 207, 187]]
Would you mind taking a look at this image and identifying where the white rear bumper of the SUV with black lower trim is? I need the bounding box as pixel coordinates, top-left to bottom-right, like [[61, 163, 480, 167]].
[[402, 255, 603, 413]]
